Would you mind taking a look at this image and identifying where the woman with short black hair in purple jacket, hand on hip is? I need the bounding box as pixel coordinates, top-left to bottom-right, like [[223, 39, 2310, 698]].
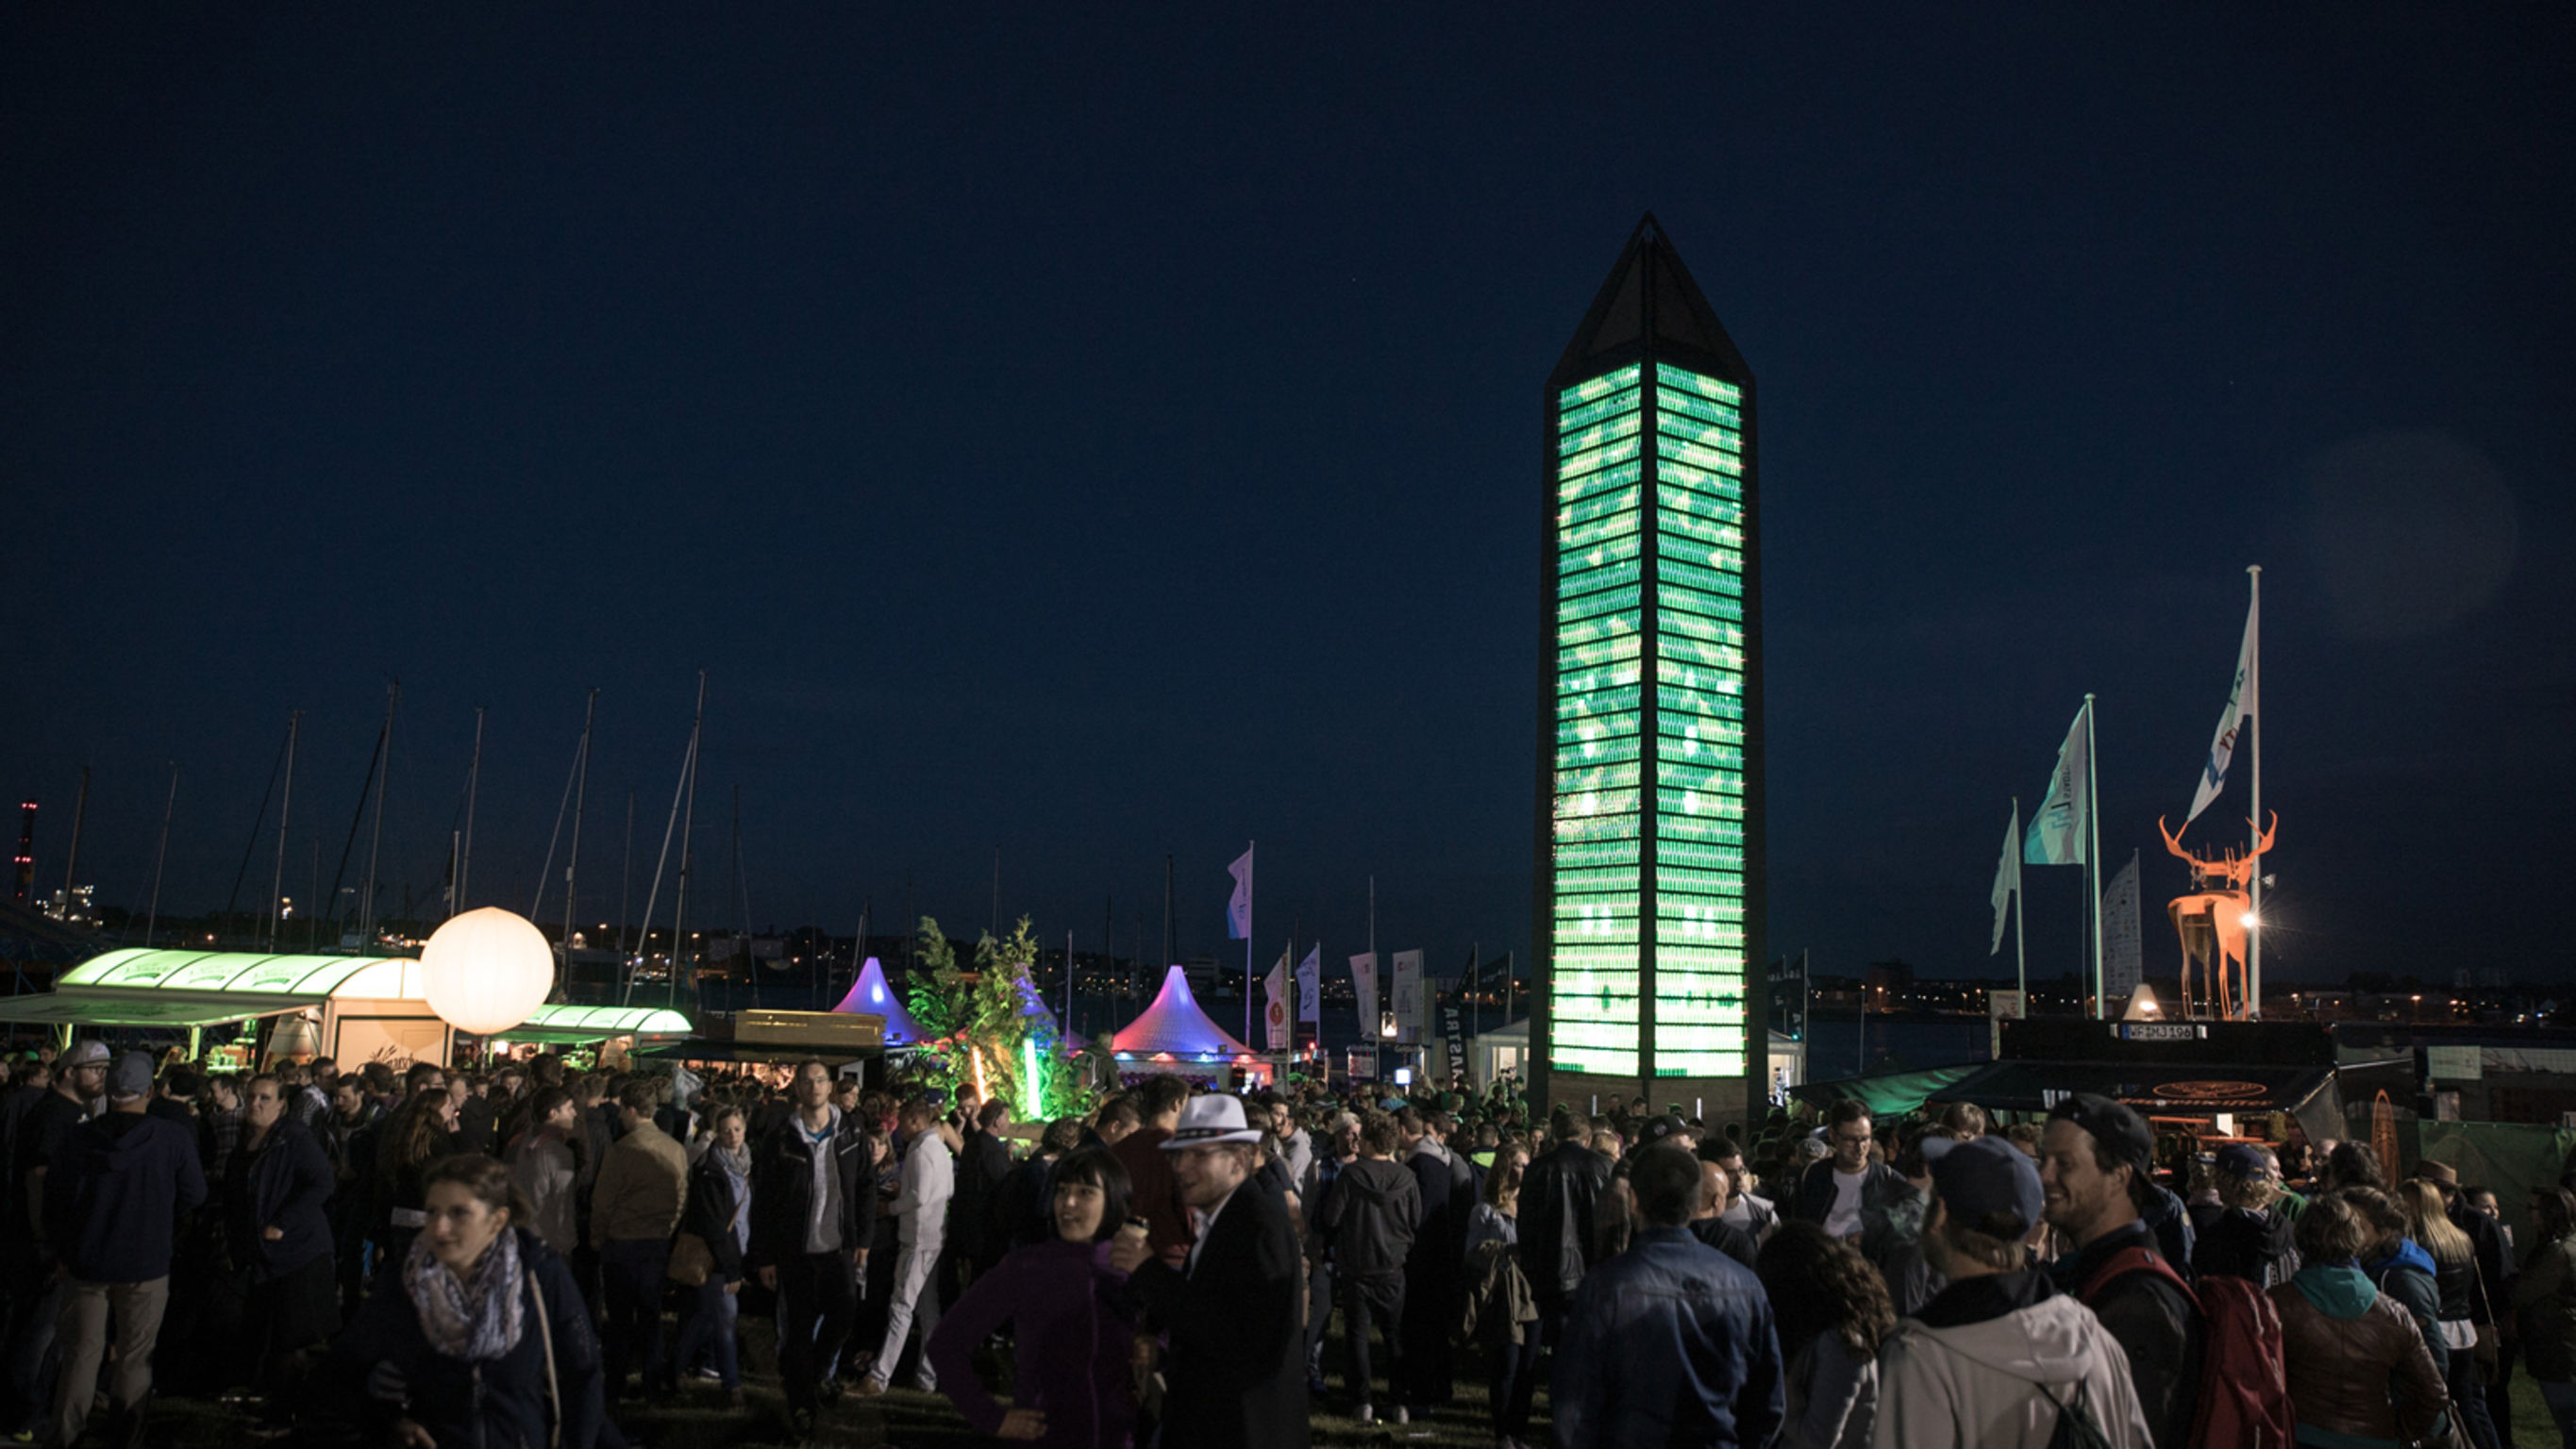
[[928, 1148, 1136, 1449]]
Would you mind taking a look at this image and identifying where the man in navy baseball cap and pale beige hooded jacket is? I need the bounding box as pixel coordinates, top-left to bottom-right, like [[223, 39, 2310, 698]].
[[1870, 1138, 2153, 1449]]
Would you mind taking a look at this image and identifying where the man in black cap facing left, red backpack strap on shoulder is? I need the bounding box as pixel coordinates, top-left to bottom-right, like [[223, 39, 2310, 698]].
[[2040, 1091, 2208, 1449]]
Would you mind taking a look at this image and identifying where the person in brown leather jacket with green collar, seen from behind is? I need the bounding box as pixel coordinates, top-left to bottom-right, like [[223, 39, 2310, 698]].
[[2267, 1191, 2445, 1449]]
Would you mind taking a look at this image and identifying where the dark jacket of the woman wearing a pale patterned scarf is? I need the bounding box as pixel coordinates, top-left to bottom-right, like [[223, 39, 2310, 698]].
[[325, 1227, 606, 1449]]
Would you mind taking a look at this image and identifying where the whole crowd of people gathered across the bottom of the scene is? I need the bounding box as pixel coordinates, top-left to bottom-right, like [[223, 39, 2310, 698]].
[[0, 1042, 2576, 1449]]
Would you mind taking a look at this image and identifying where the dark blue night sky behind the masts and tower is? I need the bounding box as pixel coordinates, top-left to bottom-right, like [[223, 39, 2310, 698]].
[[0, 5, 2576, 980]]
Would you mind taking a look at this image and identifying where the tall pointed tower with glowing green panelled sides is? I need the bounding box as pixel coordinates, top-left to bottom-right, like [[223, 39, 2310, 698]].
[[1531, 216, 1770, 1120]]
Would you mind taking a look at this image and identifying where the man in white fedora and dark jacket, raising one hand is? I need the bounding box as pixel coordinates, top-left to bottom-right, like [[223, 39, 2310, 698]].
[[1111, 1094, 1313, 1449]]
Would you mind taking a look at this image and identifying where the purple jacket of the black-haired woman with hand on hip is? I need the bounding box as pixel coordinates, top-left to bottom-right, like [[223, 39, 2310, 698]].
[[925, 1238, 1136, 1449]]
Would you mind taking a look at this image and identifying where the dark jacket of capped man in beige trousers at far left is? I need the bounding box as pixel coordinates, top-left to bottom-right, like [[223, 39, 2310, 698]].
[[43, 1112, 206, 1282]]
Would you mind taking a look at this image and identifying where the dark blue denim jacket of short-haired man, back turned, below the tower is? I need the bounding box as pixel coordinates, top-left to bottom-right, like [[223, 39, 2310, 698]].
[[1548, 1227, 1788, 1446]]
